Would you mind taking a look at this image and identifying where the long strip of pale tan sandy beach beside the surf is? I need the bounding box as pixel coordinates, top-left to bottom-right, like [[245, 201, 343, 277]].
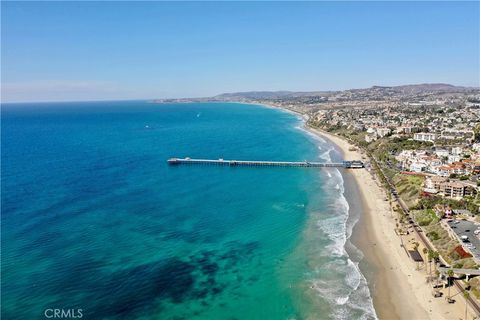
[[309, 128, 473, 320]]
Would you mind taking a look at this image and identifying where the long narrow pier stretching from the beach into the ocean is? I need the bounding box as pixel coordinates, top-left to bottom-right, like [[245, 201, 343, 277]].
[[167, 158, 364, 169]]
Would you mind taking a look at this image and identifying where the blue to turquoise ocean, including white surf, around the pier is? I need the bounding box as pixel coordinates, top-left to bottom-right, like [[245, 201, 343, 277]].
[[1, 101, 375, 319]]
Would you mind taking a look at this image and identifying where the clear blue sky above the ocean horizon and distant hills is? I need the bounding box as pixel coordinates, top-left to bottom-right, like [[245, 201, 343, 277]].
[[1, 1, 480, 102]]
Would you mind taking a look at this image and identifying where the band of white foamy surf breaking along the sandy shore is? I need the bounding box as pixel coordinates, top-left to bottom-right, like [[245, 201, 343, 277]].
[[288, 114, 377, 320]]
